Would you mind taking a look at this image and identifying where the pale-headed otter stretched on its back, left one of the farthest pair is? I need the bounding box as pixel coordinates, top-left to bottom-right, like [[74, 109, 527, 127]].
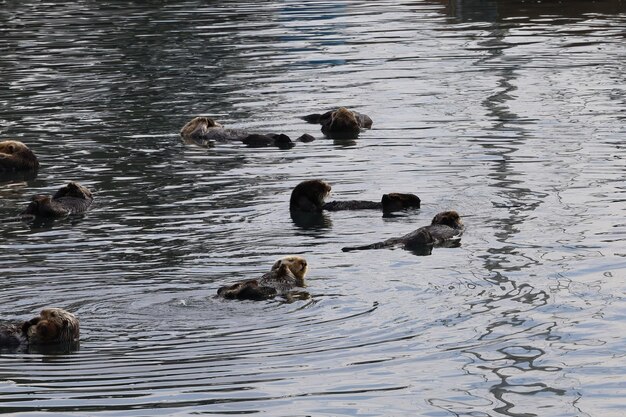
[[180, 116, 294, 149]]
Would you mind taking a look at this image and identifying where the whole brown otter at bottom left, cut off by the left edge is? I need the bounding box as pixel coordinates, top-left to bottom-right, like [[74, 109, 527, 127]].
[[0, 308, 80, 348]]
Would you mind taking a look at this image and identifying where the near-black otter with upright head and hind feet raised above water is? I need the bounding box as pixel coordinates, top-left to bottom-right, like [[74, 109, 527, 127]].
[[289, 180, 420, 213]]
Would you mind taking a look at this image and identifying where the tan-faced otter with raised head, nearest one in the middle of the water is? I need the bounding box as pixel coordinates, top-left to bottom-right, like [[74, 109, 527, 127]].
[[217, 255, 308, 301]]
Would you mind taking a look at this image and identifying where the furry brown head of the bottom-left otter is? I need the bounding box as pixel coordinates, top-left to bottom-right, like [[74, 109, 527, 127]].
[[22, 308, 80, 345]]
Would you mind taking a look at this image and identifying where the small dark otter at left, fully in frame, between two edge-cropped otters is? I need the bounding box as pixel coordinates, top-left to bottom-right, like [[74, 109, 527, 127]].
[[20, 181, 93, 217]]
